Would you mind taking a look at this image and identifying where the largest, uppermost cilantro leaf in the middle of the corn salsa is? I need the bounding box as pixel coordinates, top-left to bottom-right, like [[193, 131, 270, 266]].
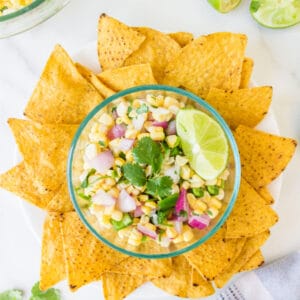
[[132, 137, 163, 173]]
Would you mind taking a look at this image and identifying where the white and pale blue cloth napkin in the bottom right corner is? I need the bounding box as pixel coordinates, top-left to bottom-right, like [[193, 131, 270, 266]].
[[217, 251, 300, 300]]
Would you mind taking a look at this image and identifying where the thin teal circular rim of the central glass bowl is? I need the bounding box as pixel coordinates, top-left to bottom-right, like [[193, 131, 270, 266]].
[[67, 84, 241, 259]]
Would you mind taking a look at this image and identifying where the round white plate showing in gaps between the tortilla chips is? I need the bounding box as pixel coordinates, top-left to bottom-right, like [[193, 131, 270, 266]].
[[15, 42, 282, 300]]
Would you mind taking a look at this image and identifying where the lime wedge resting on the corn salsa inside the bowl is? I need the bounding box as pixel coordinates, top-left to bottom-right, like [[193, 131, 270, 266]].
[[176, 109, 229, 180]]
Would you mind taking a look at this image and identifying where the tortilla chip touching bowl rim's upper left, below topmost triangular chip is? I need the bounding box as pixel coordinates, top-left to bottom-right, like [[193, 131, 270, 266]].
[[98, 64, 156, 91]]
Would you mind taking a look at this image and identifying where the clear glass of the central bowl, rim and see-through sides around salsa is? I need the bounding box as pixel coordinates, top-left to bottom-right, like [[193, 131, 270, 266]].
[[67, 85, 241, 259]]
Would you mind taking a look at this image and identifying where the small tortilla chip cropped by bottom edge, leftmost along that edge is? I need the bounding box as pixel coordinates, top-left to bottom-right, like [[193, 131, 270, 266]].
[[102, 272, 147, 300]]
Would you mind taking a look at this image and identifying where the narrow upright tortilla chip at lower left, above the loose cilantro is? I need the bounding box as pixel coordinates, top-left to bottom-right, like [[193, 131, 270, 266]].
[[40, 213, 66, 291]]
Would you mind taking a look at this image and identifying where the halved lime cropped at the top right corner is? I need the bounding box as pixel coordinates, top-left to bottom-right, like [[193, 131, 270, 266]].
[[250, 0, 300, 28]]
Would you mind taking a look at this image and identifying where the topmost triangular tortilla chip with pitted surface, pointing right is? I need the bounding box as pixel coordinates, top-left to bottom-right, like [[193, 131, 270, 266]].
[[98, 14, 145, 71]]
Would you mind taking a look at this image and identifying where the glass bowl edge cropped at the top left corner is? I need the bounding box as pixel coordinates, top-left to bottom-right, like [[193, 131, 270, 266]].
[[0, 0, 70, 38]]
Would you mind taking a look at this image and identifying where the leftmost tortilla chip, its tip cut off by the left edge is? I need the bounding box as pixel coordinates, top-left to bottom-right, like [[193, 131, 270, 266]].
[[0, 162, 54, 209]]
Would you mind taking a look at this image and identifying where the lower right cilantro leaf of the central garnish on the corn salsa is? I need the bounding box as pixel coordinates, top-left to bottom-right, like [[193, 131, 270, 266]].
[[147, 176, 173, 198]]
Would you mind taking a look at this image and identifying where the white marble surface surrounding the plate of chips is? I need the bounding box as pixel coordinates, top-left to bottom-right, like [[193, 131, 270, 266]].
[[0, 0, 300, 300]]
